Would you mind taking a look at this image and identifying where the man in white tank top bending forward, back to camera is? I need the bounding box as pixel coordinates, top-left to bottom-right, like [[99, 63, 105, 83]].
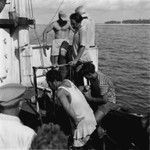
[[46, 70, 96, 149]]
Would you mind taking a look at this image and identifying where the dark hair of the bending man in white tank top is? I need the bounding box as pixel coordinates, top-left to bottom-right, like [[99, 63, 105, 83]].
[[46, 69, 62, 82]]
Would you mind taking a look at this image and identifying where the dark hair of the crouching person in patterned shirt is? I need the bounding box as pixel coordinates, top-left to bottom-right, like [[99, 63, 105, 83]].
[[81, 62, 95, 76]]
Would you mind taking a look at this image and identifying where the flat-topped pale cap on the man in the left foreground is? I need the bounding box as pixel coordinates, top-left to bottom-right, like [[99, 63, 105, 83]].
[[0, 83, 26, 106]]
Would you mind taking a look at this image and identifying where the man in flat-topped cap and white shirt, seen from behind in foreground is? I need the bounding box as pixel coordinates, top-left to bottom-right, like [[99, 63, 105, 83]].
[[0, 83, 36, 150]]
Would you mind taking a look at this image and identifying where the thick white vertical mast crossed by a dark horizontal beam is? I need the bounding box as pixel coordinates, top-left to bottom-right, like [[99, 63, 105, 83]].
[[17, 0, 31, 86]]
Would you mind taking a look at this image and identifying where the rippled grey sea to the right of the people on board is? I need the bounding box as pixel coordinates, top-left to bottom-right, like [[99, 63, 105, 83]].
[[96, 25, 150, 113]]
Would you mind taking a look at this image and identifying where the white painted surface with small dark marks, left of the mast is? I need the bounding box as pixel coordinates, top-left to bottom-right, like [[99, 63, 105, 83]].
[[0, 28, 19, 85]]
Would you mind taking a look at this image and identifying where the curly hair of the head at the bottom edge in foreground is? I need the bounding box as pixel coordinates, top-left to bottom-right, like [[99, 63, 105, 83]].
[[30, 123, 67, 150]]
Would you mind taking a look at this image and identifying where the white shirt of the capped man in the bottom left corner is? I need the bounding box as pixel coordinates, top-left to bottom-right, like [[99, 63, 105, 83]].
[[0, 114, 36, 150]]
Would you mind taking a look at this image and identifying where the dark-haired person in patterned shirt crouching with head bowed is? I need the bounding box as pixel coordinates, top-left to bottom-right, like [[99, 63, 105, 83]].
[[80, 62, 120, 136]]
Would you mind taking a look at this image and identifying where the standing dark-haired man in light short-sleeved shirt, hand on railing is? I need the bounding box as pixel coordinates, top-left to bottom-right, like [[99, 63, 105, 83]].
[[70, 13, 91, 90]]
